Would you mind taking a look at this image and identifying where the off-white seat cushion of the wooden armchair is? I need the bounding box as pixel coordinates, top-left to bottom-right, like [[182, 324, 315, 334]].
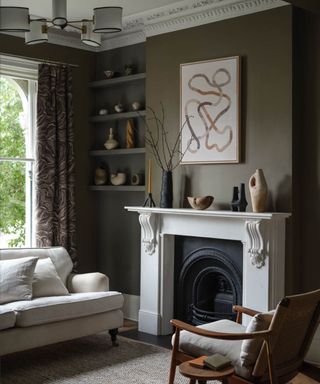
[[179, 320, 252, 378]]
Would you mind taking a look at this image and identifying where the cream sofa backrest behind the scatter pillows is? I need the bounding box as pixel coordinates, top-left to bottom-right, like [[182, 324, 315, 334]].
[[0, 247, 73, 285]]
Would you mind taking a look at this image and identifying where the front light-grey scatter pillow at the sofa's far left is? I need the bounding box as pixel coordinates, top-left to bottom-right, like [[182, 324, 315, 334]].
[[0, 257, 38, 304]]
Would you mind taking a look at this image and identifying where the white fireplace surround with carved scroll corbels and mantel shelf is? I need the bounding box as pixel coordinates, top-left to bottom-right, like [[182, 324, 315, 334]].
[[126, 207, 290, 335]]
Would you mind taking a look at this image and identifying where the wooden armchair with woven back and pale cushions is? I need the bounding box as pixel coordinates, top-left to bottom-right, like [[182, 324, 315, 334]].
[[169, 289, 320, 384]]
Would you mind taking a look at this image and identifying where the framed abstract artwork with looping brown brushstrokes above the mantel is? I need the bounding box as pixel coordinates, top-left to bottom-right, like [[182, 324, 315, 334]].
[[180, 56, 240, 164]]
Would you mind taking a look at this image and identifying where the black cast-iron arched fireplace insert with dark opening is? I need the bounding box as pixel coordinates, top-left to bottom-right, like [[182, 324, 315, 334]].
[[175, 247, 242, 325]]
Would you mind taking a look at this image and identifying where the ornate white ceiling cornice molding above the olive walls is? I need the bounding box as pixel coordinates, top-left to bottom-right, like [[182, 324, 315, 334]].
[[0, 0, 288, 52]]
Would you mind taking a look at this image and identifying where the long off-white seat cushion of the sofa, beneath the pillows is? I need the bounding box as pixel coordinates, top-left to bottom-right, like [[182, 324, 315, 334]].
[[4, 291, 123, 327]]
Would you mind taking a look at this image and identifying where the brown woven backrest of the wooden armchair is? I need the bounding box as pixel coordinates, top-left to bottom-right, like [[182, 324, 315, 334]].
[[252, 289, 320, 378]]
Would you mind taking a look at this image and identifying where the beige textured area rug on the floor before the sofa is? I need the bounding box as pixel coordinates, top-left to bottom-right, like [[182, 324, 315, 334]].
[[0, 333, 189, 384]]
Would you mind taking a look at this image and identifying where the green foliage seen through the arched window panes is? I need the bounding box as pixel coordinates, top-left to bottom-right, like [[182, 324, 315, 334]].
[[0, 77, 26, 247]]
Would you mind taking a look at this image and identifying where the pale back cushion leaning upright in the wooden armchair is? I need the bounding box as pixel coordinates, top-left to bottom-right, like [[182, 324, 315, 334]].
[[240, 310, 275, 367]]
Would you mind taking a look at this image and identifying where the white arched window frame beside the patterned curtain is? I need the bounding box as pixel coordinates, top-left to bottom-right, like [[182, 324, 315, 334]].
[[0, 55, 38, 247]]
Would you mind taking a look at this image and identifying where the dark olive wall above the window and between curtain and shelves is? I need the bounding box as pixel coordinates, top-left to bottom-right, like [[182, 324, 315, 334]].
[[0, 34, 96, 271]]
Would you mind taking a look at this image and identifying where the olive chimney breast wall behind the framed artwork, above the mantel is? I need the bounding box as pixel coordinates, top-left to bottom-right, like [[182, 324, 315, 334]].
[[146, 6, 297, 291]]
